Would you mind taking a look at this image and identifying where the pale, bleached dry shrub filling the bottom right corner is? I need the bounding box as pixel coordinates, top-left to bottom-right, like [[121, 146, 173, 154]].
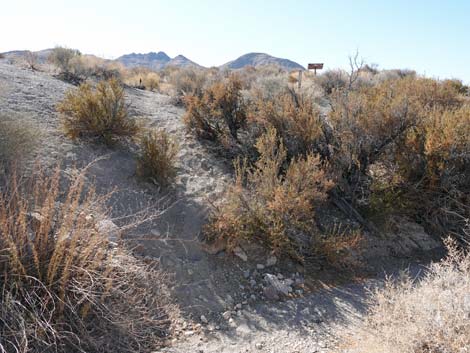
[[348, 236, 470, 353]]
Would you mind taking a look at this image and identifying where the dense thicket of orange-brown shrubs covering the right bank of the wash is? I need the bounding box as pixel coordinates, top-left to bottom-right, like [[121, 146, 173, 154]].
[[185, 56, 470, 262]]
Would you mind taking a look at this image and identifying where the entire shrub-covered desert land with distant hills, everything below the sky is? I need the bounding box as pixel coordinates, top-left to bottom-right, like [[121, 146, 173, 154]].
[[0, 47, 470, 353]]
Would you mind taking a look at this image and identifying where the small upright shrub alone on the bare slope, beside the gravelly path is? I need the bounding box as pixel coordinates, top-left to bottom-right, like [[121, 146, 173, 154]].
[[137, 130, 178, 186]]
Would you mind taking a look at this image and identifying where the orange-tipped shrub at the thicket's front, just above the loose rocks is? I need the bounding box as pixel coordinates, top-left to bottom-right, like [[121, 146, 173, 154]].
[[206, 129, 332, 259]]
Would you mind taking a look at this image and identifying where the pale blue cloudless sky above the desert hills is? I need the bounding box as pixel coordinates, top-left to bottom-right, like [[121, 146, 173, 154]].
[[0, 0, 470, 82]]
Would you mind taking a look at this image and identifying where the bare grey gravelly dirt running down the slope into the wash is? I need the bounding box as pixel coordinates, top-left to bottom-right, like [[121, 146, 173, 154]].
[[0, 60, 440, 353]]
